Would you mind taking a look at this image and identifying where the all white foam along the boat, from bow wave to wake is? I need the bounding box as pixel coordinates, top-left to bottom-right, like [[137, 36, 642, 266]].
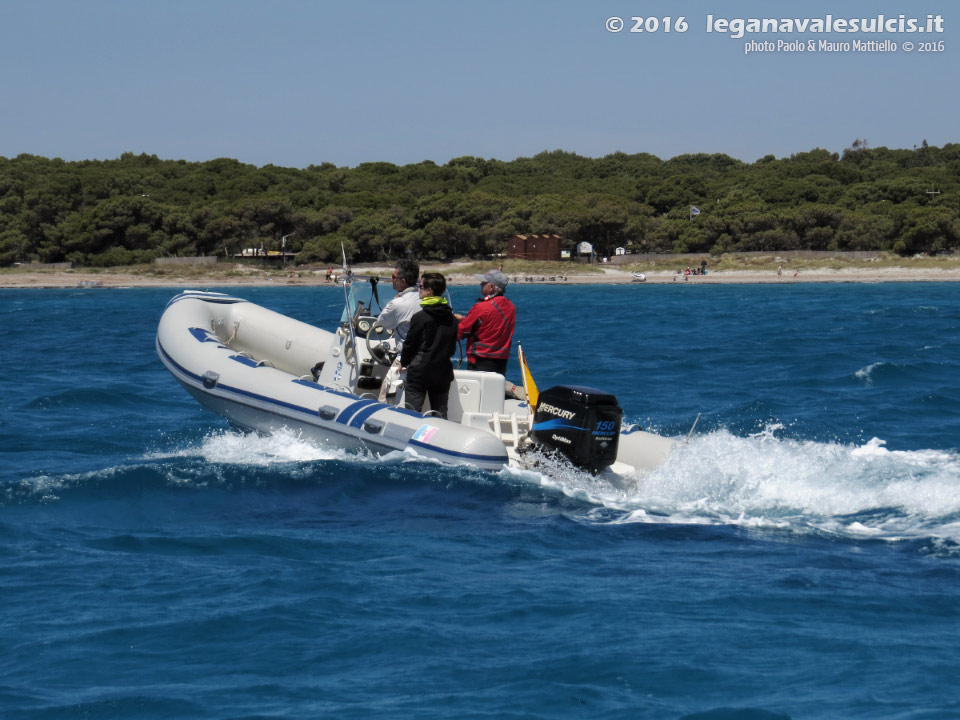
[[7, 424, 960, 542]]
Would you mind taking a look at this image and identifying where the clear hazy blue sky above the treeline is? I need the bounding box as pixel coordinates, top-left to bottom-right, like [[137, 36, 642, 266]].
[[0, 0, 960, 167]]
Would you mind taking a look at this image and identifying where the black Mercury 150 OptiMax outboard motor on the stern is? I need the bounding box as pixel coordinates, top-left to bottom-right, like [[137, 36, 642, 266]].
[[530, 385, 623, 473]]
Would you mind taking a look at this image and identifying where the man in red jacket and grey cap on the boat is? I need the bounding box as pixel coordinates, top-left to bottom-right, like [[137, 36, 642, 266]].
[[454, 270, 517, 375]]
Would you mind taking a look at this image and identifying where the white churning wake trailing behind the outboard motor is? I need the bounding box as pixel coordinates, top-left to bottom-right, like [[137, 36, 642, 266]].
[[502, 425, 960, 542]]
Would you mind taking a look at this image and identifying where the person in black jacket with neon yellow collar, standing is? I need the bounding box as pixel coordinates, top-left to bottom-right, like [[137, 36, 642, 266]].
[[400, 273, 457, 418]]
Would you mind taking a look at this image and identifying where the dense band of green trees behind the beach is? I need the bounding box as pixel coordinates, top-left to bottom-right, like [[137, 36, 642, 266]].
[[0, 142, 960, 265]]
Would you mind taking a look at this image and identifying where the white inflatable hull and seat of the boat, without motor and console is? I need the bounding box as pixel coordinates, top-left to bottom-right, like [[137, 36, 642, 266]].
[[156, 292, 674, 472]]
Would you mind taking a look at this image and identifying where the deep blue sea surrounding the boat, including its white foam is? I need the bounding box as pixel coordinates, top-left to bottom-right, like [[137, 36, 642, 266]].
[[0, 282, 960, 720]]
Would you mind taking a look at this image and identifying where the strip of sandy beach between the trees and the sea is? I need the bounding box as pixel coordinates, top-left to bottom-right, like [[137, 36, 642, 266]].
[[0, 265, 960, 289]]
